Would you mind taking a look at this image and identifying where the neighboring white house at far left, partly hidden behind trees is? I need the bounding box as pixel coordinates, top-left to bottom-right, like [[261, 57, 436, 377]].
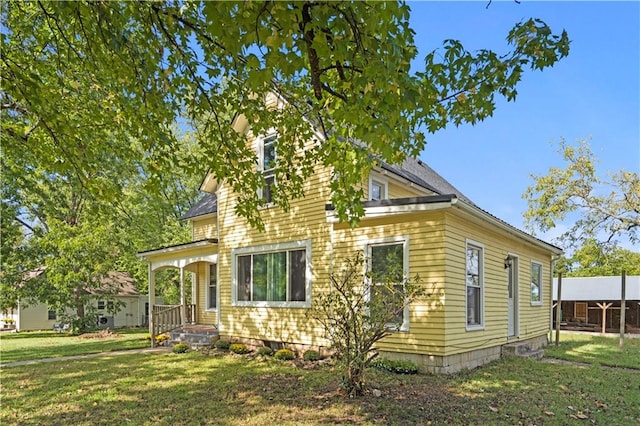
[[2, 272, 162, 331]]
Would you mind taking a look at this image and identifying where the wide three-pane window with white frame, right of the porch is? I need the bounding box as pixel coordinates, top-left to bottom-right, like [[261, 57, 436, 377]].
[[232, 240, 311, 307]]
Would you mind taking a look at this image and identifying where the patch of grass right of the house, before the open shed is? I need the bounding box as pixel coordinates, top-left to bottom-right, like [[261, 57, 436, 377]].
[[544, 331, 640, 370]]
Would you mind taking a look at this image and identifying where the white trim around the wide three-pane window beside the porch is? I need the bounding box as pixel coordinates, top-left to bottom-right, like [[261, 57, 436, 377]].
[[231, 239, 312, 308]]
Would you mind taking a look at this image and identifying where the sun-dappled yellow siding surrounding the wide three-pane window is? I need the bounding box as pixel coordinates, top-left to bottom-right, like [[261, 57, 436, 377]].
[[218, 135, 331, 345]]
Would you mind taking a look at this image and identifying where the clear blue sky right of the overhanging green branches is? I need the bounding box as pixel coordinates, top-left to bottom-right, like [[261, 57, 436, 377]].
[[408, 1, 640, 240]]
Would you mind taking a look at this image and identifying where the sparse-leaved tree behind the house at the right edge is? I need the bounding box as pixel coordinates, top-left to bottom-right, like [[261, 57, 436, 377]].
[[523, 140, 640, 248]]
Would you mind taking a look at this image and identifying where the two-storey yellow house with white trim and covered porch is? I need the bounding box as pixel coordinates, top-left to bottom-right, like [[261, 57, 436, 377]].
[[139, 111, 561, 372]]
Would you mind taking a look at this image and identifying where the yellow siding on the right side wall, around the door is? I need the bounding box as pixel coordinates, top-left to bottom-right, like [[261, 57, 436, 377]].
[[445, 213, 551, 355]]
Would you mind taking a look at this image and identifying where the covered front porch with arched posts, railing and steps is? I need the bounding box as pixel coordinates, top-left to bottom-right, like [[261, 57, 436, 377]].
[[138, 239, 218, 346]]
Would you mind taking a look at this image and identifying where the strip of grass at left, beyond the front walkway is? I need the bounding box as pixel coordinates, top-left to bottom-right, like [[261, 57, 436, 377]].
[[0, 328, 149, 364]]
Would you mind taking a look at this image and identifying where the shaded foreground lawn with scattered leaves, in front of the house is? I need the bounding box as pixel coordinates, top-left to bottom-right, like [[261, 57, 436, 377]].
[[0, 332, 640, 425]]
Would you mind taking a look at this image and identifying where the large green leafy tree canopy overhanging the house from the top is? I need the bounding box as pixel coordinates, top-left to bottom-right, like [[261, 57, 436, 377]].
[[0, 0, 569, 230]]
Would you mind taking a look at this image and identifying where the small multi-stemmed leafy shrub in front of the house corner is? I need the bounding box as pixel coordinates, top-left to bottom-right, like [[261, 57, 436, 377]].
[[310, 252, 425, 397]]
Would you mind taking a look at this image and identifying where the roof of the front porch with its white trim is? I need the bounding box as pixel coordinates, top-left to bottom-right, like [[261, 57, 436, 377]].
[[137, 238, 218, 271]]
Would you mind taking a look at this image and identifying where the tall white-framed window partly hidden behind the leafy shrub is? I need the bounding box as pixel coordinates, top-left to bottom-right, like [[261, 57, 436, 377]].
[[367, 239, 409, 331]]
